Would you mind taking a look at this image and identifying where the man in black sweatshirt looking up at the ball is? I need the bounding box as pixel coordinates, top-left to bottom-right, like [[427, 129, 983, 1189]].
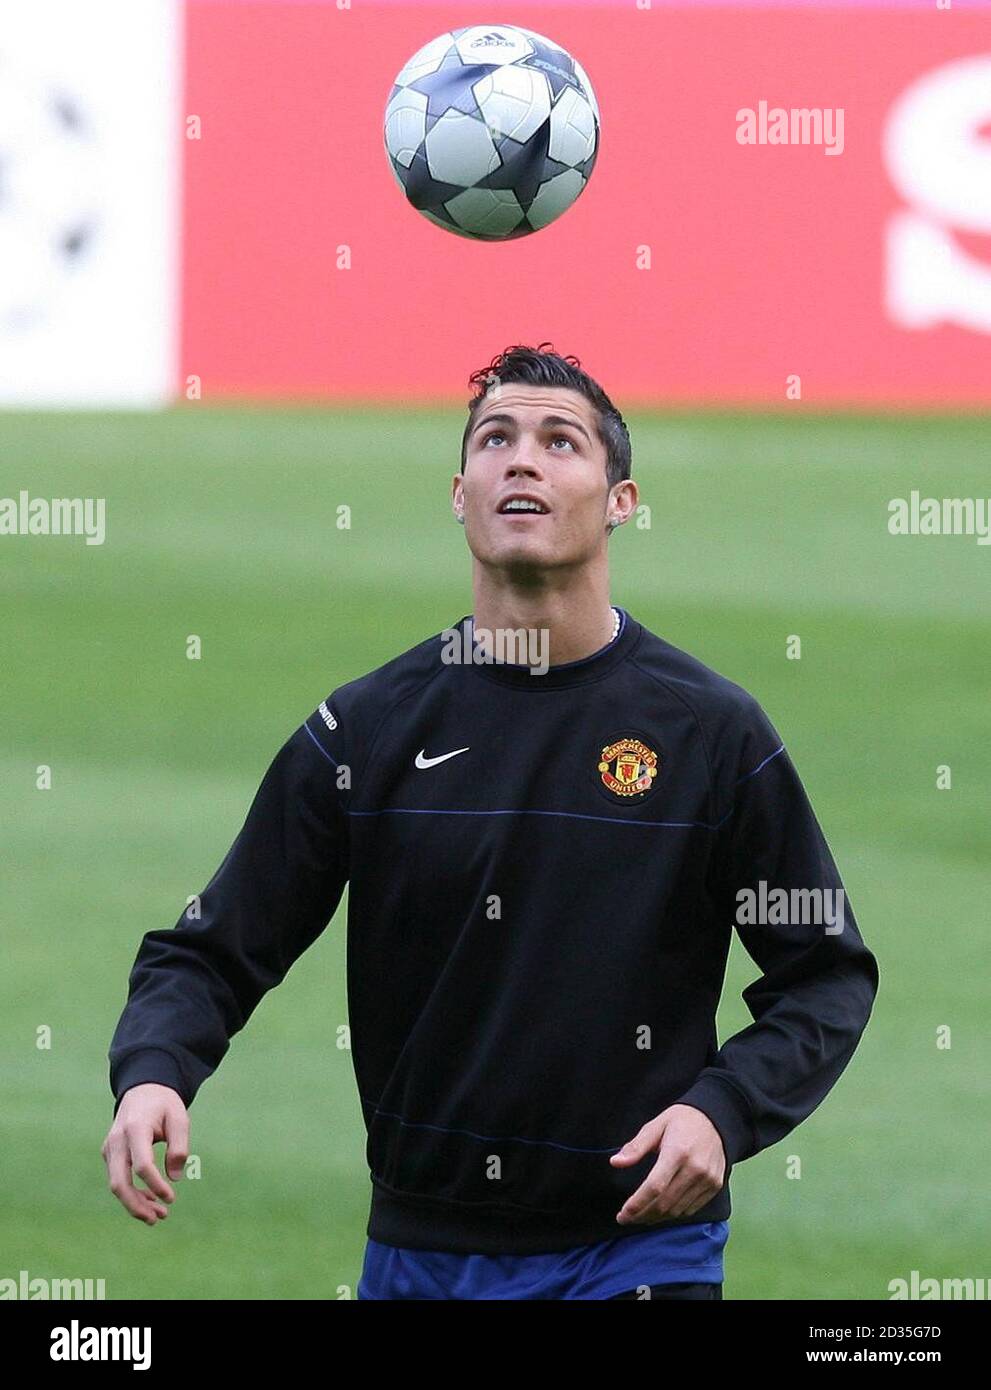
[[103, 343, 877, 1298]]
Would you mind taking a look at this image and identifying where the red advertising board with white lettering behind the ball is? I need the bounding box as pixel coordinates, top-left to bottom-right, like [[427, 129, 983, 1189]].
[[181, 0, 991, 406]]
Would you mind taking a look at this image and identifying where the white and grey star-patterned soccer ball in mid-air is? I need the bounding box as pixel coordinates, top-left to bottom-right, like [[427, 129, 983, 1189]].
[[385, 24, 599, 242]]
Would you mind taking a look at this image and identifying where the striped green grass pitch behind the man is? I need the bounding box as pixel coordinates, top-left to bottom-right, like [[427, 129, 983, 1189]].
[[0, 406, 991, 1300]]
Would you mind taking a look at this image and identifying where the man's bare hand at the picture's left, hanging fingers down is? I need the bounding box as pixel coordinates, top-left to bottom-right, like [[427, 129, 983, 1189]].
[[100, 1081, 189, 1226]]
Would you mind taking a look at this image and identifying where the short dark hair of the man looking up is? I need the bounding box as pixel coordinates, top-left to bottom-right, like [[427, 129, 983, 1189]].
[[461, 342, 632, 488]]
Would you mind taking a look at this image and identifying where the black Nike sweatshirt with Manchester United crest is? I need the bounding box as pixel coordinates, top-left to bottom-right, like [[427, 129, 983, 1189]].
[[110, 613, 878, 1254]]
